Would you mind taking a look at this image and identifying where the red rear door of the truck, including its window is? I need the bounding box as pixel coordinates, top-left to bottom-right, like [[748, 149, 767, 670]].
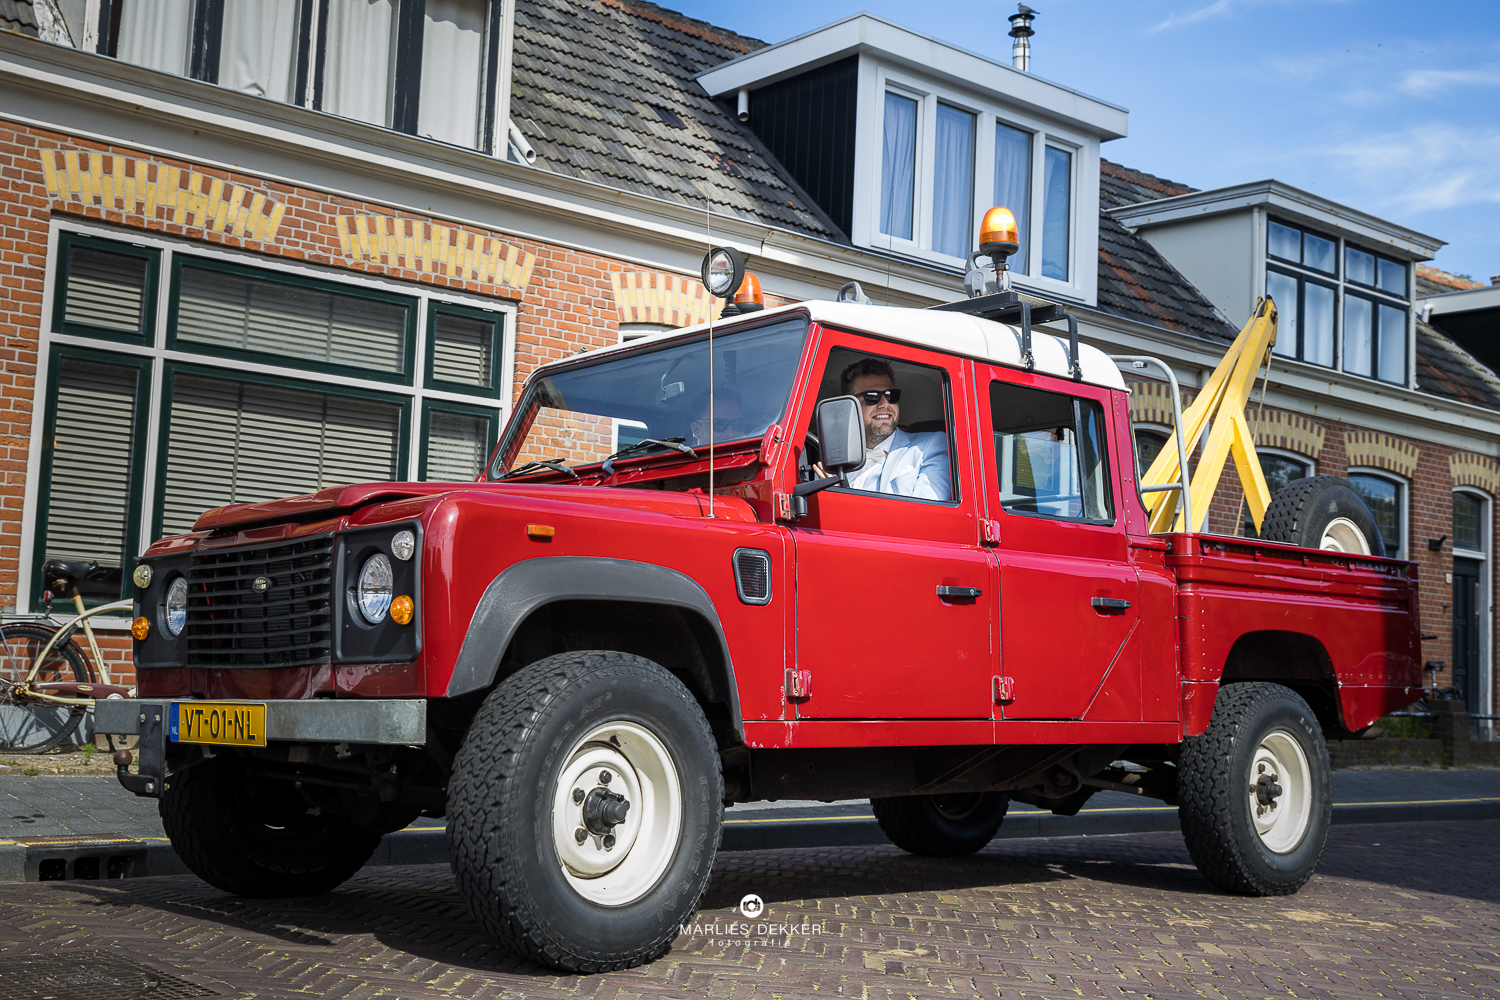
[[981, 366, 1140, 719]]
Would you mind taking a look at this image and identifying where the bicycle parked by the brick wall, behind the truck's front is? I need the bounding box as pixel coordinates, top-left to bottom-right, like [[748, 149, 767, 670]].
[[0, 559, 134, 754]]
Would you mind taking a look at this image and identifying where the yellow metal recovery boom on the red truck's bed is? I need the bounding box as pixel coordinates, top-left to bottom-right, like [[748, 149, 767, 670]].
[[1140, 297, 1277, 532]]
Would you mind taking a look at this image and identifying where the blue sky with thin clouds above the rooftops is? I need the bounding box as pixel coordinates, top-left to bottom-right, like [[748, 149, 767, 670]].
[[672, 0, 1500, 283]]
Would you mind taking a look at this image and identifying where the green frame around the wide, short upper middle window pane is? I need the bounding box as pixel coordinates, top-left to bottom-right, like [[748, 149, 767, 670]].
[[167, 252, 419, 385]]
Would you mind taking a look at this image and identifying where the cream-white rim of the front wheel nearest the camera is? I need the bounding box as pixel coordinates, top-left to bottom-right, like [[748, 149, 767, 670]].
[[552, 723, 683, 906]]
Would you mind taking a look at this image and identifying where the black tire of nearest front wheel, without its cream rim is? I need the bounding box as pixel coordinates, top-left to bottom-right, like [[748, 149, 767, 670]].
[[447, 651, 723, 973]]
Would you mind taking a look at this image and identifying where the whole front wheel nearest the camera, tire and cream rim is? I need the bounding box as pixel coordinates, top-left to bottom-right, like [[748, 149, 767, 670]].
[[449, 651, 723, 973]]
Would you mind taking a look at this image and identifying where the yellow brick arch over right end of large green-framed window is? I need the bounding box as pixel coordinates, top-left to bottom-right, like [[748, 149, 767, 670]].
[[333, 214, 537, 292]]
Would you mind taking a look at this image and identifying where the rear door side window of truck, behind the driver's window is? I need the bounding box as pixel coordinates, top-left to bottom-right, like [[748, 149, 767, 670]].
[[990, 382, 1115, 520]]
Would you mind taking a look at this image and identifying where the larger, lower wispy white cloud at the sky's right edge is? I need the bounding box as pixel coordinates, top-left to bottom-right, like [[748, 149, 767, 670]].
[[1323, 123, 1500, 214]]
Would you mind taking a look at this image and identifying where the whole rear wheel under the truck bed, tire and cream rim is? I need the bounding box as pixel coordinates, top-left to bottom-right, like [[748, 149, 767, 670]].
[[1178, 681, 1334, 897]]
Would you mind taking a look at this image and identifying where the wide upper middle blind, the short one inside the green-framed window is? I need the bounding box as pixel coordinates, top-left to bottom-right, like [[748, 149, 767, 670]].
[[177, 267, 411, 372]]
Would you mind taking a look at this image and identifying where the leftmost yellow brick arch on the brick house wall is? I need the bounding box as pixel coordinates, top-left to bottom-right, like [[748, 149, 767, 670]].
[[38, 150, 287, 243]]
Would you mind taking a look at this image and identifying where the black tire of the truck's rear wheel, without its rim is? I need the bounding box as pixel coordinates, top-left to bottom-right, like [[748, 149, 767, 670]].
[[1178, 681, 1334, 897]]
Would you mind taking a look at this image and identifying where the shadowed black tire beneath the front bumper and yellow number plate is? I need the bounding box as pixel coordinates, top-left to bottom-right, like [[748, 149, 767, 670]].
[[158, 750, 380, 898]]
